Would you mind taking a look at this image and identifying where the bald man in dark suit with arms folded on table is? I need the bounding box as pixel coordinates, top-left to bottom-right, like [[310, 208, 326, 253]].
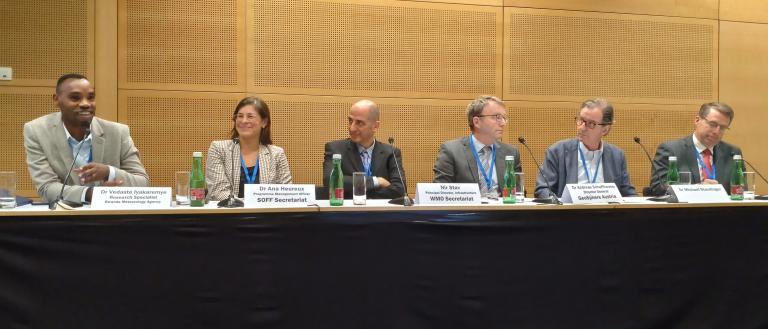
[[323, 100, 405, 199]]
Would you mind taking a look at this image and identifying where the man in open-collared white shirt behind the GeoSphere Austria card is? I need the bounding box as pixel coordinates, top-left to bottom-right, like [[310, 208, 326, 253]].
[[535, 98, 636, 198]]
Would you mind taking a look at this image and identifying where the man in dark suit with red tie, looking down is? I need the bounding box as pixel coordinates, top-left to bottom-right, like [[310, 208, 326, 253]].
[[651, 103, 741, 195]]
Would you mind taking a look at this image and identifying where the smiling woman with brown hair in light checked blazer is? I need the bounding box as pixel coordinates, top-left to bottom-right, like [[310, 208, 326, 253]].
[[205, 97, 292, 201]]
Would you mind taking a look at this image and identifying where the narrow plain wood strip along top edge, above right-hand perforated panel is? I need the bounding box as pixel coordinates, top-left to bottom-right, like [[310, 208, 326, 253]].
[[504, 0, 716, 19]]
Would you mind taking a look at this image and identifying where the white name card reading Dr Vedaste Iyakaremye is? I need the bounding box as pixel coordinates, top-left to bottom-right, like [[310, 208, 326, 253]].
[[91, 186, 171, 210]]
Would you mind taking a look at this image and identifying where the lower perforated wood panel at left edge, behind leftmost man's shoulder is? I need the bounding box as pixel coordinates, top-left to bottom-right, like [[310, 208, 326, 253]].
[[0, 87, 63, 197]]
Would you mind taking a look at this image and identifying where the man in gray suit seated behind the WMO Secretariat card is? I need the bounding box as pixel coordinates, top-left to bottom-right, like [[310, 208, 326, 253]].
[[432, 96, 522, 198]]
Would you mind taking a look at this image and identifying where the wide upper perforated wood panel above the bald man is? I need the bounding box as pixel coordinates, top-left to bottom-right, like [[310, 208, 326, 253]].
[[248, 0, 503, 99]]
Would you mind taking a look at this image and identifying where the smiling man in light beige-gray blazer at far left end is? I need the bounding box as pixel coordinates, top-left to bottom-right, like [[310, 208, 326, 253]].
[[24, 74, 149, 203]]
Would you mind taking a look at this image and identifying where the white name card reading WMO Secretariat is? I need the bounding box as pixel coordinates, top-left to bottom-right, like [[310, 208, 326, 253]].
[[416, 183, 481, 204]]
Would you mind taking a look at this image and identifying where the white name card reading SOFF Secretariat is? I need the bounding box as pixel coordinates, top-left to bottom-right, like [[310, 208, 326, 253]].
[[243, 184, 316, 208]]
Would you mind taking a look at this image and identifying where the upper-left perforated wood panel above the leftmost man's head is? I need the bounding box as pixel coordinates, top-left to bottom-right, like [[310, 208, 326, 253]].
[[0, 0, 94, 86]]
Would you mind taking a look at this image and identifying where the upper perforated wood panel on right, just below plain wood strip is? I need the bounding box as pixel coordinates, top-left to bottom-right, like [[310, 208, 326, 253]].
[[504, 8, 718, 104]]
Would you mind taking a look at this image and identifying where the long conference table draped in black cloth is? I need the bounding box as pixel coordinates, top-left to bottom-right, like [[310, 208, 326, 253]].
[[0, 198, 768, 328]]
